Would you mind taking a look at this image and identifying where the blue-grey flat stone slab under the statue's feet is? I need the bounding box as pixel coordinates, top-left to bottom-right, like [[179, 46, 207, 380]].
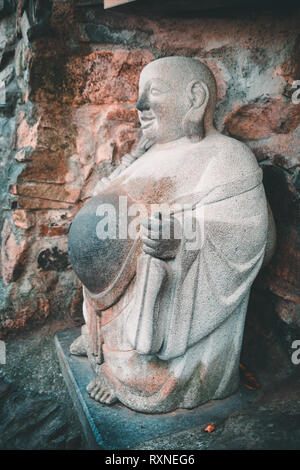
[[55, 328, 256, 450]]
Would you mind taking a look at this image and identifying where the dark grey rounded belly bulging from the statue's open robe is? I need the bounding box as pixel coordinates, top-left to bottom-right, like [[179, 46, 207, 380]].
[[68, 185, 141, 309]]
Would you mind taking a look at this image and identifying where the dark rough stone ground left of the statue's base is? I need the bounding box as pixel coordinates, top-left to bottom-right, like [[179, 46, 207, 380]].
[[0, 325, 85, 450]]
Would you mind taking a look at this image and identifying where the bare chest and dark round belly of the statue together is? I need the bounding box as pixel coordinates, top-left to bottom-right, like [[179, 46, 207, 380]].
[[69, 172, 191, 309]]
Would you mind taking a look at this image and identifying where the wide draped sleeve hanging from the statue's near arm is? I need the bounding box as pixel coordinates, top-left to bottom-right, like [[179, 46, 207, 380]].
[[127, 168, 267, 360]]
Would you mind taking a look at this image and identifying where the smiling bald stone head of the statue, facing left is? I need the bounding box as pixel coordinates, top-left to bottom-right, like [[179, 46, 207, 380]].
[[137, 56, 217, 142]]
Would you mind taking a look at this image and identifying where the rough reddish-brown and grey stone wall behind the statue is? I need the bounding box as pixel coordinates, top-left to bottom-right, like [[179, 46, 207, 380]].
[[0, 1, 300, 350]]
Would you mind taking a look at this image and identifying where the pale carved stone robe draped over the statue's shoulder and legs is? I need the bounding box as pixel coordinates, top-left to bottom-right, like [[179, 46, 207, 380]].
[[84, 133, 269, 413]]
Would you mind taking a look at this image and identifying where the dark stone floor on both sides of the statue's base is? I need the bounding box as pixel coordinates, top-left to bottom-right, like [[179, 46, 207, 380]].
[[0, 318, 300, 450]]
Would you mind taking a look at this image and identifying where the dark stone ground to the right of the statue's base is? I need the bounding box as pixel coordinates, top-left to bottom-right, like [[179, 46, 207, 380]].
[[136, 377, 300, 450]]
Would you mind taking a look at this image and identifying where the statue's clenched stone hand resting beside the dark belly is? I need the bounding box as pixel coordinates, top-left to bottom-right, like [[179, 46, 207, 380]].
[[141, 213, 180, 259]]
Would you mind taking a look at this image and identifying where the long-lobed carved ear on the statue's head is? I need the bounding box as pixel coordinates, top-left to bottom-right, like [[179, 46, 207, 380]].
[[183, 80, 209, 140]]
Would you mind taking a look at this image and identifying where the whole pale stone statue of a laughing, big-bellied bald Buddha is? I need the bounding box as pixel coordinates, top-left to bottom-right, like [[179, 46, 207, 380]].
[[69, 57, 275, 413]]
